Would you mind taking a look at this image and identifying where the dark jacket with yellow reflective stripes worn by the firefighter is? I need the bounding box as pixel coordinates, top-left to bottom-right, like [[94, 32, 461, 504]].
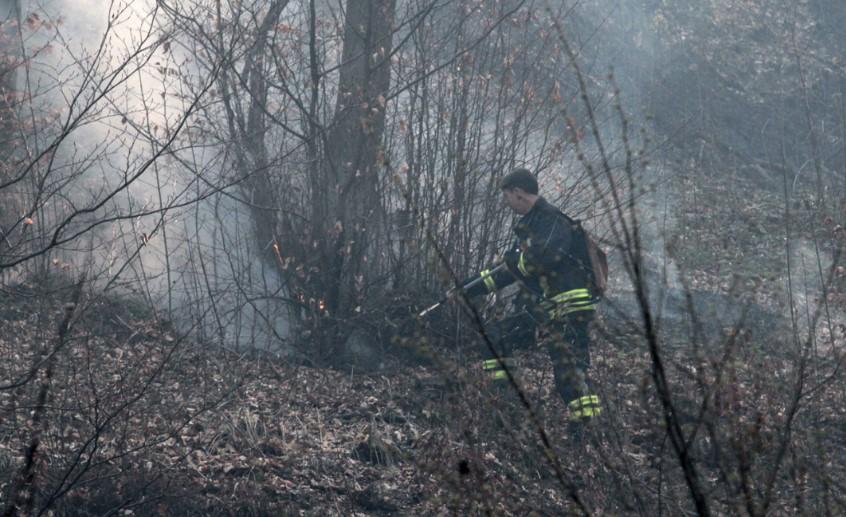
[[464, 197, 597, 319]]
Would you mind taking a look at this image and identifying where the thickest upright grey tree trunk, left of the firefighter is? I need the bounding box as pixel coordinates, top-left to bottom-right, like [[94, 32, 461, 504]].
[[324, 0, 396, 318]]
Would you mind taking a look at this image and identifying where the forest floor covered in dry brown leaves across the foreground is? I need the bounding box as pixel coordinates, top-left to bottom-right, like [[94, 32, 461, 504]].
[[0, 270, 846, 515]]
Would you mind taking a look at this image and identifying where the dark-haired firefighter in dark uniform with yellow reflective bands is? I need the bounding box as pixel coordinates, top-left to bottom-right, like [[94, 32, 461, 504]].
[[463, 169, 601, 438]]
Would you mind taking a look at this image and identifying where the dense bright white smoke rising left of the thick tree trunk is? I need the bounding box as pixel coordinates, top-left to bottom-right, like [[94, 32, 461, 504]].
[[3, 0, 294, 348]]
